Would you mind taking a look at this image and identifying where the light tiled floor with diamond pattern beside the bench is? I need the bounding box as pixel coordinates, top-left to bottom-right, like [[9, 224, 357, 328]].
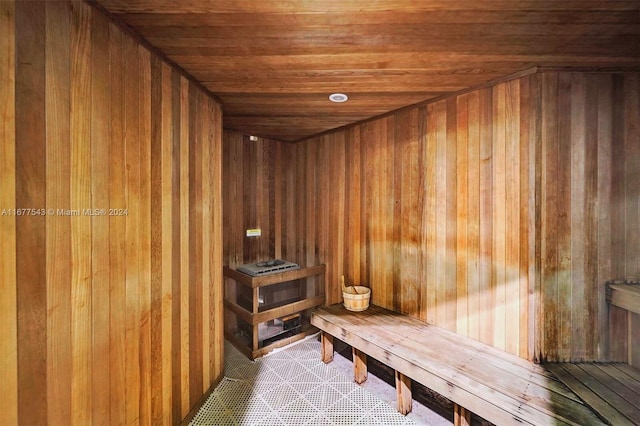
[[191, 336, 450, 426]]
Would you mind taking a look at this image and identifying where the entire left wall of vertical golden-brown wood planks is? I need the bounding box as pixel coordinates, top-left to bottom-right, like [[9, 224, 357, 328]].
[[0, 1, 223, 425]]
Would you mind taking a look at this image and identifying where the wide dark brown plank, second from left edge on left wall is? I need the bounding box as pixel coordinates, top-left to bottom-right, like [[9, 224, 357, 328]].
[[15, 2, 47, 425]]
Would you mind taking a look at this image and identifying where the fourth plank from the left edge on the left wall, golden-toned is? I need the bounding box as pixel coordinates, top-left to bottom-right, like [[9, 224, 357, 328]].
[[70, 3, 93, 424]]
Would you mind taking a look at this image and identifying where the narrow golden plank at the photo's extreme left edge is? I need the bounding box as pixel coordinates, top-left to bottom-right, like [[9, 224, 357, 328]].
[[0, 1, 17, 424]]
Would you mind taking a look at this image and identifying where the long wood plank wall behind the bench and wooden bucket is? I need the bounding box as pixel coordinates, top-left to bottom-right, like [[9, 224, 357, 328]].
[[283, 76, 537, 357]]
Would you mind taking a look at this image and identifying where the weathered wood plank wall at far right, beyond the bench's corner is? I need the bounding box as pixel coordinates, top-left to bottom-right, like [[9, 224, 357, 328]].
[[538, 72, 640, 361]]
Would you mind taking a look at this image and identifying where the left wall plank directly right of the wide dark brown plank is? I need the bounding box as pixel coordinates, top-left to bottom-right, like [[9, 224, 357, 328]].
[[45, 2, 70, 424]]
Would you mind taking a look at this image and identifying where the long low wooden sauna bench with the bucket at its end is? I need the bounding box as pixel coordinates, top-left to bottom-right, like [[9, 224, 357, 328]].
[[311, 304, 604, 425]]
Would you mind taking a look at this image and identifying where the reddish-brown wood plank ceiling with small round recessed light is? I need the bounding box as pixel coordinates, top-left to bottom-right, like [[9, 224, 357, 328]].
[[92, 0, 640, 141]]
